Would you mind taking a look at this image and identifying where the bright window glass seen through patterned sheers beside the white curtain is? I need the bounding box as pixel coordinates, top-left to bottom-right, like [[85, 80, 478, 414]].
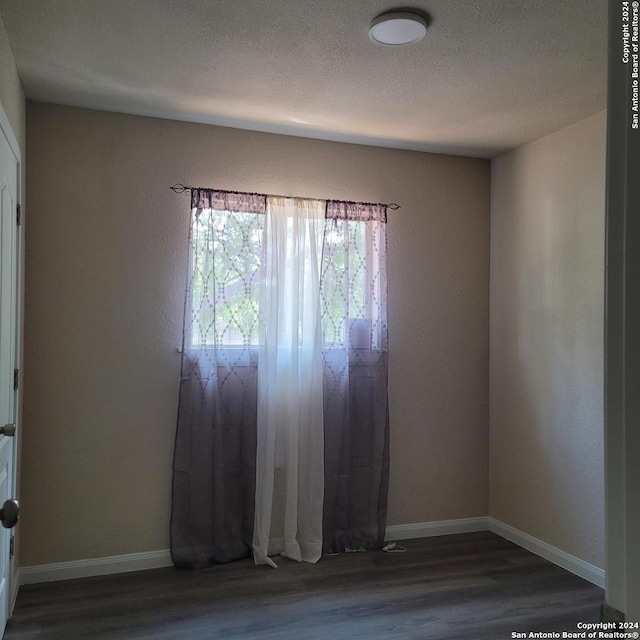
[[185, 200, 386, 350]]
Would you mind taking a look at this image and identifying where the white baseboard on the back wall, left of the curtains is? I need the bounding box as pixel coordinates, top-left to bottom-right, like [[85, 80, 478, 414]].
[[20, 550, 172, 585]]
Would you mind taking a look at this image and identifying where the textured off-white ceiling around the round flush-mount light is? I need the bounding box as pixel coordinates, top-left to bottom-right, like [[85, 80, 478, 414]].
[[0, 0, 607, 157]]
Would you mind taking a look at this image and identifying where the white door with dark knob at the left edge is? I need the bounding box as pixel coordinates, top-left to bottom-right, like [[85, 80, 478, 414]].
[[0, 116, 19, 636]]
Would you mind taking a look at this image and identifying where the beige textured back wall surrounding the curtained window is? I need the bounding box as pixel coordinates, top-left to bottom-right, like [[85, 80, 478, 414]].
[[21, 104, 489, 565]]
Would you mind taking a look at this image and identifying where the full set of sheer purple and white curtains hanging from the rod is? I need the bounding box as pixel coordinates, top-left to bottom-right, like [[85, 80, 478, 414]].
[[171, 189, 389, 568]]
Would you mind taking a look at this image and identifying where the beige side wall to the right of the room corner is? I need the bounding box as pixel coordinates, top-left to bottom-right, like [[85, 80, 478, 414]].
[[490, 113, 606, 567]]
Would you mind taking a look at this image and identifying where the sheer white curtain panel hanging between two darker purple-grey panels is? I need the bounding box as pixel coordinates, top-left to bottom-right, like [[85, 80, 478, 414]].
[[253, 196, 326, 567]]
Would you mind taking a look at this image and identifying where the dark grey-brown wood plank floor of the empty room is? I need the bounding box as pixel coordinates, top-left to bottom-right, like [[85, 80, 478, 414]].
[[5, 532, 604, 640]]
